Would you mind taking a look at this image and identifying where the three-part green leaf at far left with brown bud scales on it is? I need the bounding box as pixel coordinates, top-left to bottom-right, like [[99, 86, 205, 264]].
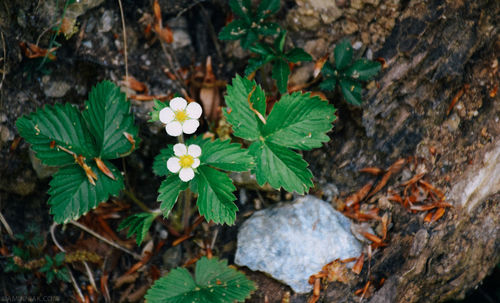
[[16, 81, 139, 223]]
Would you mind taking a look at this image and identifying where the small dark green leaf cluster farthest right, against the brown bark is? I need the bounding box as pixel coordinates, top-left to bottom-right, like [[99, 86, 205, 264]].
[[320, 39, 381, 106]]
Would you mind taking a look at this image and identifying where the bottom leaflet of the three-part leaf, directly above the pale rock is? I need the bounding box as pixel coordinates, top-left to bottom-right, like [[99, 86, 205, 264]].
[[249, 141, 313, 194]]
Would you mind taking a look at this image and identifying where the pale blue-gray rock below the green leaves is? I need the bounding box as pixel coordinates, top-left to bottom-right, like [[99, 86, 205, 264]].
[[235, 196, 362, 293]]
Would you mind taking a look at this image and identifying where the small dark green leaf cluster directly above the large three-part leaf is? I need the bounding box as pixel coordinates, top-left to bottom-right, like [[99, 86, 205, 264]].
[[245, 31, 312, 93]]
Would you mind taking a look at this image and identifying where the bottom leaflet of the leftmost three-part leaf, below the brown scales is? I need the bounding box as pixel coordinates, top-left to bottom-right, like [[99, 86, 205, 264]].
[[48, 161, 124, 223]]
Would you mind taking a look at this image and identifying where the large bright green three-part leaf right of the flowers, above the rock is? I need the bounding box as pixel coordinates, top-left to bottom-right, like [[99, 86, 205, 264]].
[[224, 76, 336, 194]]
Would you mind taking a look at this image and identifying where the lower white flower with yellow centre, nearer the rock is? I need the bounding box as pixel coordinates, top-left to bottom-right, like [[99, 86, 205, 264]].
[[167, 143, 201, 182]]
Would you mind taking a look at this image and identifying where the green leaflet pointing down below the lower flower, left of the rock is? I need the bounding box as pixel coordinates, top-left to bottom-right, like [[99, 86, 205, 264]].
[[191, 165, 238, 225]]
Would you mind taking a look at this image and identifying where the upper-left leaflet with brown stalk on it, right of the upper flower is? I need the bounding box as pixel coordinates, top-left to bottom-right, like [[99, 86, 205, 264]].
[[224, 75, 266, 141]]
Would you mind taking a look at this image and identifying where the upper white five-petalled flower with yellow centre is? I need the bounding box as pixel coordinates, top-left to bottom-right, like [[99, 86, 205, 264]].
[[160, 97, 202, 137]]
